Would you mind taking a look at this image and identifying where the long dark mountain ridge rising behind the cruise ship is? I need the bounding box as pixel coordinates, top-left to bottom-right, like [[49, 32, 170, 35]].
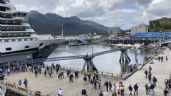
[[27, 11, 108, 35]]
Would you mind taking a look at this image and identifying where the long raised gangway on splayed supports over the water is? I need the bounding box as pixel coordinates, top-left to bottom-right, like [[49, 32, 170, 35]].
[[26, 47, 130, 72]]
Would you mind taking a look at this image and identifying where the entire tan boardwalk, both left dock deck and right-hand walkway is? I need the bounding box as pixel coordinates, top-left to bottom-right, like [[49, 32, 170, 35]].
[[5, 49, 171, 96]]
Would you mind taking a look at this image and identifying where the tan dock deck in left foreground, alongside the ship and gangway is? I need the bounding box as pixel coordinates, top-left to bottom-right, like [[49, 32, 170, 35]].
[[5, 72, 119, 96]]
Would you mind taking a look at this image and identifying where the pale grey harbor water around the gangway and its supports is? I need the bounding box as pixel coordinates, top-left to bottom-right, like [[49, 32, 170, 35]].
[[44, 44, 152, 74]]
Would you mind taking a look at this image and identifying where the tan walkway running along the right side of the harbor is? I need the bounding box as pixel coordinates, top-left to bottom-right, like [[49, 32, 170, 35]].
[[124, 49, 171, 96]]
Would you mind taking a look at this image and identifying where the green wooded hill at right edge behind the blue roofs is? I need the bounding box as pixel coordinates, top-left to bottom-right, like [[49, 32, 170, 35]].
[[149, 17, 171, 32]]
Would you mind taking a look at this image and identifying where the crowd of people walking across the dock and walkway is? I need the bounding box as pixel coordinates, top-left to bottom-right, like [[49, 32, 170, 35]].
[[0, 51, 171, 96]]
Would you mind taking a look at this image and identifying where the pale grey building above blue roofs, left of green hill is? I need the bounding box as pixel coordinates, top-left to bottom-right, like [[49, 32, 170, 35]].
[[131, 23, 148, 34]]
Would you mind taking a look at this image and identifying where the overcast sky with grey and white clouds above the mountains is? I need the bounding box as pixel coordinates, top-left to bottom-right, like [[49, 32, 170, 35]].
[[10, 0, 171, 29]]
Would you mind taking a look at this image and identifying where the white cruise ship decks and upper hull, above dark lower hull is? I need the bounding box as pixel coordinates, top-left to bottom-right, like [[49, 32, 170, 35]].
[[0, 0, 65, 55]]
